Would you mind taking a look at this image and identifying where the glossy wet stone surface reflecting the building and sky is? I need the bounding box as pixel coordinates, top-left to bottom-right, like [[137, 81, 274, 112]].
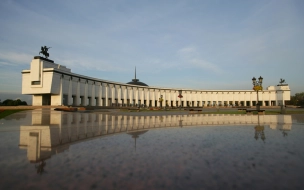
[[0, 109, 304, 189]]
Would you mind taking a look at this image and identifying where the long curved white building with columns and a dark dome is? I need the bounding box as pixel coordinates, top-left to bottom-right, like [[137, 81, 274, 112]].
[[22, 56, 290, 107]]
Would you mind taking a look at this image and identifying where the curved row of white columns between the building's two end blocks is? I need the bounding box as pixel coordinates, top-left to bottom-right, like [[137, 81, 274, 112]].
[[61, 76, 289, 107]]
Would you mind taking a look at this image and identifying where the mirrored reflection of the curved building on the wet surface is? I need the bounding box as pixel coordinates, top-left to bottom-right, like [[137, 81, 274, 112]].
[[19, 110, 292, 173]]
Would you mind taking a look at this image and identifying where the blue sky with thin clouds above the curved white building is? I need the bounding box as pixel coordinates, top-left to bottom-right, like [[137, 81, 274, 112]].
[[0, 0, 304, 104]]
